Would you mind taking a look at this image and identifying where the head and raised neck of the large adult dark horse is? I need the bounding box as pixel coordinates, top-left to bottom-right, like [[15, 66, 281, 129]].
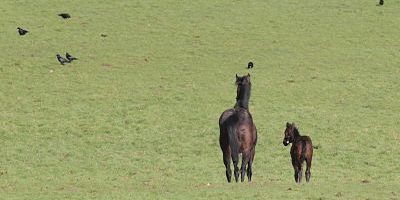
[[235, 74, 251, 109]]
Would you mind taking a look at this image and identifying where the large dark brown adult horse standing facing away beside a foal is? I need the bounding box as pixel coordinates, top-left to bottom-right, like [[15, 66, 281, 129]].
[[219, 74, 257, 182]]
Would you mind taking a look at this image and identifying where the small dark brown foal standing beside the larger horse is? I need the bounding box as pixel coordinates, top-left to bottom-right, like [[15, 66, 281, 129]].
[[283, 122, 313, 183]]
